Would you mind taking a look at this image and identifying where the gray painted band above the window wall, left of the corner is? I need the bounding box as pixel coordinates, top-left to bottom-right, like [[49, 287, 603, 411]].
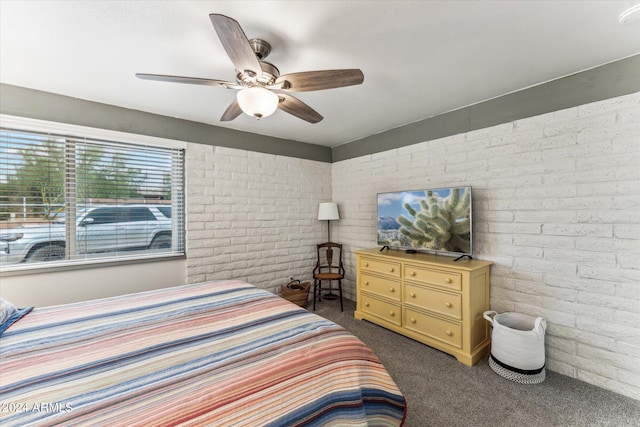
[[0, 84, 331, 162]]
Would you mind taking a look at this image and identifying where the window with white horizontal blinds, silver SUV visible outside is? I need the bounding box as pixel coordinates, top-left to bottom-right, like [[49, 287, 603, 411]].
[[0, 127, 184, 271]]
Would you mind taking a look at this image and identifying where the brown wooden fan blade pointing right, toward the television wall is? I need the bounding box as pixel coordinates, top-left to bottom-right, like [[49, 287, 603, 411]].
[[274, 69, 364, 92]]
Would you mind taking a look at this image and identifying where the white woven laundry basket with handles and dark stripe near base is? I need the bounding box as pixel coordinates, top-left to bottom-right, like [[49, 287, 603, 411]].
[[484, 311, 547, 384]]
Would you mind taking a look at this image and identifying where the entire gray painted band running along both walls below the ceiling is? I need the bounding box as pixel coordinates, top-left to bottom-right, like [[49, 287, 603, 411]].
[[0, 55, 640, 162]]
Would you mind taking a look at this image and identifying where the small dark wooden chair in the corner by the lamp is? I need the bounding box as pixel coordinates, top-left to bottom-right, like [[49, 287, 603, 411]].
[[313, 242, 344, 311]]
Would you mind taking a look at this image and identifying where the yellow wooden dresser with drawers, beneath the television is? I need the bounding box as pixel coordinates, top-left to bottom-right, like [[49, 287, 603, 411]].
[[355, 248, 492, 366]]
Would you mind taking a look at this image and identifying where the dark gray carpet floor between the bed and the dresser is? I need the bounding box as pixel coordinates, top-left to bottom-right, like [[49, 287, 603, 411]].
[[314, 300, 640, 427]]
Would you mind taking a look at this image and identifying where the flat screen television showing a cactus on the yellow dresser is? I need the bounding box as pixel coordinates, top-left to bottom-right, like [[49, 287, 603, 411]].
[[378, 187, 473, 258]]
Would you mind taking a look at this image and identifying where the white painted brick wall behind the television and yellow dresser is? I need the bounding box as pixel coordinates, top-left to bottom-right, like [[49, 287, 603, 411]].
[[331, 93, 640, 399]]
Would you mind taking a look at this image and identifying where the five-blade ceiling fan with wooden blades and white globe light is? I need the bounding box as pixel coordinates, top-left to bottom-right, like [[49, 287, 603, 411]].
[[136, 13, 364, 123]]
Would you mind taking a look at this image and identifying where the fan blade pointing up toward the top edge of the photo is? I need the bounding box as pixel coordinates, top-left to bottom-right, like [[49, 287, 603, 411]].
[[209, 13, 262, 77]]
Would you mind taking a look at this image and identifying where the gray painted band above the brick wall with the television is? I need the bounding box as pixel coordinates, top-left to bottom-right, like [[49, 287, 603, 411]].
[[332, 55, 640, 162]]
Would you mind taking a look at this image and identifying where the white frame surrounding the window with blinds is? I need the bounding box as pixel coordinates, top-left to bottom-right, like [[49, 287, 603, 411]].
[[0, 114, 187, 278]]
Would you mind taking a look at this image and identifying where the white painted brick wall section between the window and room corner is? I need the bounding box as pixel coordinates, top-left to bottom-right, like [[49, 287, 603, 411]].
[[186, 144, 331, 293]]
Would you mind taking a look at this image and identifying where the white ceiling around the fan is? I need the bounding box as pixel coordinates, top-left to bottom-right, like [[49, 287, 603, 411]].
[[0, 0, 640, 146]]
